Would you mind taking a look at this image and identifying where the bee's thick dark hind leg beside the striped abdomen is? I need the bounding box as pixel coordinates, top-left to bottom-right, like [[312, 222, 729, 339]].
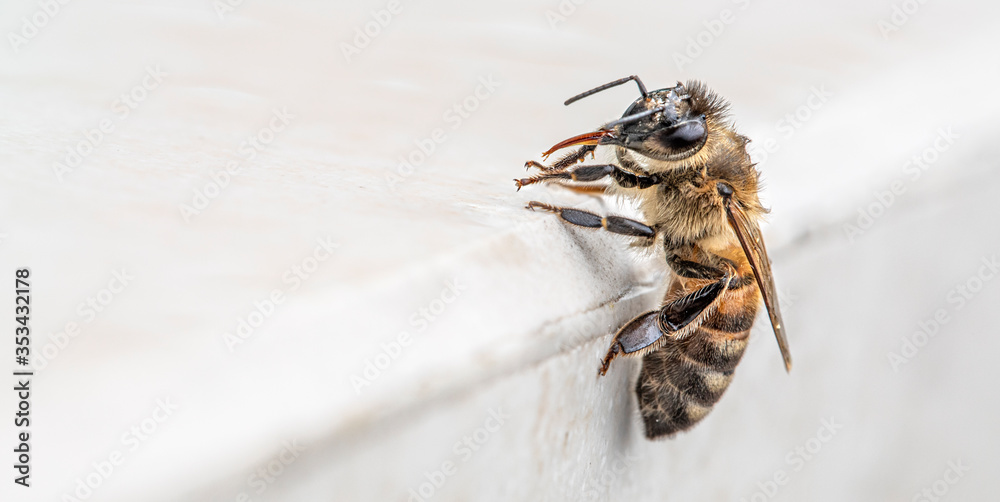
[[598, 274, 732, 375]]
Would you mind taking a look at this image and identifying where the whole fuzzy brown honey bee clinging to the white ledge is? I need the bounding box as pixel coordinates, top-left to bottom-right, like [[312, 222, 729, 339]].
[[514, 75, 792, 439]]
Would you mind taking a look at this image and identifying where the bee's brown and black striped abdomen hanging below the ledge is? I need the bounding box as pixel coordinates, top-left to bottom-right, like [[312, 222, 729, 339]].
[[635, 267, 760, 439]]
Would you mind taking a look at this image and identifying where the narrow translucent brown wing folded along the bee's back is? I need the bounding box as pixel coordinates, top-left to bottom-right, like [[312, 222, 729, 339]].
[[725, 197, 792, 371]]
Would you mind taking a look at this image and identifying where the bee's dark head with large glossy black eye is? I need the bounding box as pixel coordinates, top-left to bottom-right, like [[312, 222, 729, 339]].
[[603, 83, 708, 161]]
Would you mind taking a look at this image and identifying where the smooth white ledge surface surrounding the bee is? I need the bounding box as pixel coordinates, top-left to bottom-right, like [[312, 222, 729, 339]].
[[0, 0, 1000, 501]]
